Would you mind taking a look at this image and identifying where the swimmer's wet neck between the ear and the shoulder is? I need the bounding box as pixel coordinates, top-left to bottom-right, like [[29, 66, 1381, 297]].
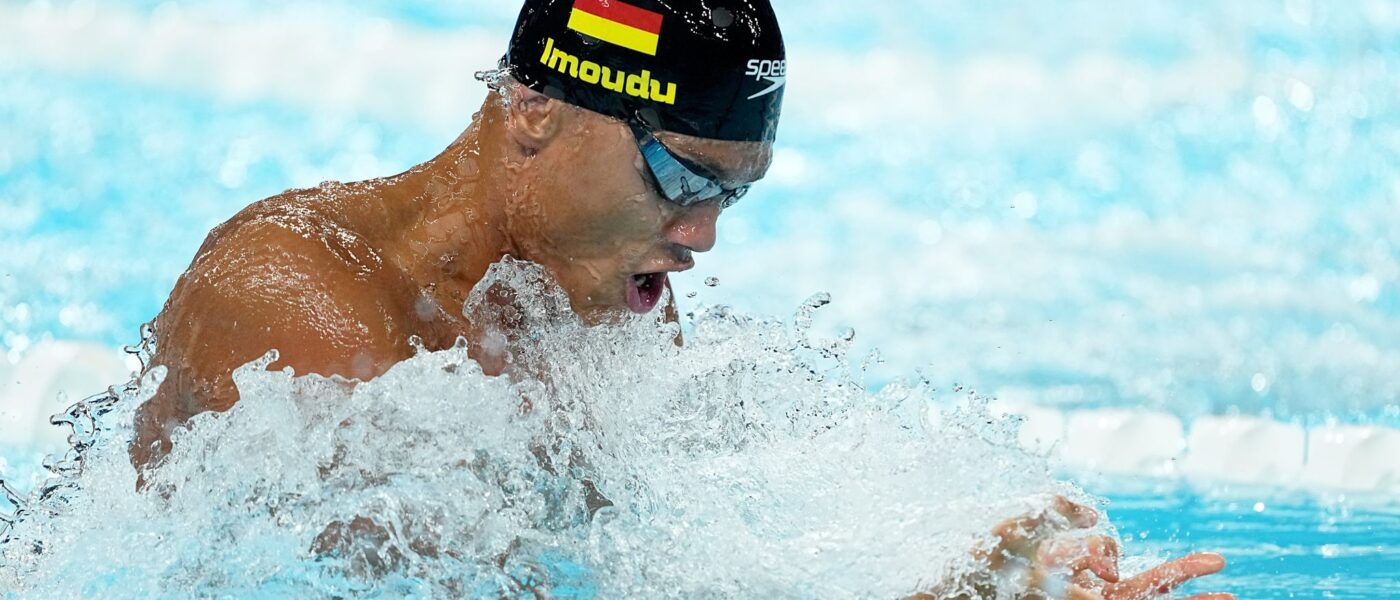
[[393, 95, 518, 320]]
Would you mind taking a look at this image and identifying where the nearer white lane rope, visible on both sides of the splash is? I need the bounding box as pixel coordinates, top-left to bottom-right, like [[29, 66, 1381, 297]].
[[0, 341, 1400, 500]]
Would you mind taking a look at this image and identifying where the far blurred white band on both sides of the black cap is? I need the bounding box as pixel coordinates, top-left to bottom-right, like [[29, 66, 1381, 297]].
[[0, 3, 1282, 137]]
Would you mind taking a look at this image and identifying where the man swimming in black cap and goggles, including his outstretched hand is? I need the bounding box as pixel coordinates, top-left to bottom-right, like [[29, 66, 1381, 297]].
[[132, 0, 1222, 599]]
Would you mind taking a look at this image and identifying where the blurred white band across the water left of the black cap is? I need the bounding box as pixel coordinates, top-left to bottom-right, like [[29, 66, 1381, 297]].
[[0, 3, 508, 129]]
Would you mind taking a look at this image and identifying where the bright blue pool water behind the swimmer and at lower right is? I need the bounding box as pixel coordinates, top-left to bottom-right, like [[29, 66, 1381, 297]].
[[0, 0, 1400, 599]]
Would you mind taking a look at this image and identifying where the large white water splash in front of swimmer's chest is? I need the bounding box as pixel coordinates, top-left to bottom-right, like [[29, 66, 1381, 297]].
[[0, 262, 1077, 597]]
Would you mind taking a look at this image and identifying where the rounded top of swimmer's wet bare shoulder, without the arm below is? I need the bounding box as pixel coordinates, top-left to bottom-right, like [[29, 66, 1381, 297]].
[[158, 192, 405, 376]]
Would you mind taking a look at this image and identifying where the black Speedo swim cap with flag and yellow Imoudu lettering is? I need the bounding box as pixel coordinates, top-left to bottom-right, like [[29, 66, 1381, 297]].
[[504, 0, 787, 141]]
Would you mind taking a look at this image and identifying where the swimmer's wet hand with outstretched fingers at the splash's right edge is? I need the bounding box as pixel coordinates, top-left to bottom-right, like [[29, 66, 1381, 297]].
[[924, 497, 1235, 600]]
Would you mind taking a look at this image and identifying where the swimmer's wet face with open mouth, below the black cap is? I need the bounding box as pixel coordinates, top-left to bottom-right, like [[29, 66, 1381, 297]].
[[508, 87, 773, 320]]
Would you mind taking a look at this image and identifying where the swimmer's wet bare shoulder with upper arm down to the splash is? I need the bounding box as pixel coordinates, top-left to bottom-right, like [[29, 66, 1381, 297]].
[[133, 187, 410, 453]]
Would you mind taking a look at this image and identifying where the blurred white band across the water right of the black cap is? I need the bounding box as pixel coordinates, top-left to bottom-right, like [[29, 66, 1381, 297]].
[[790, 48, 1249, 137]]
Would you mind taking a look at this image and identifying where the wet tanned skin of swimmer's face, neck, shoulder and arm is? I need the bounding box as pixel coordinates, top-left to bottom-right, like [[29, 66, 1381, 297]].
[[132, 84, 771, 469]]
